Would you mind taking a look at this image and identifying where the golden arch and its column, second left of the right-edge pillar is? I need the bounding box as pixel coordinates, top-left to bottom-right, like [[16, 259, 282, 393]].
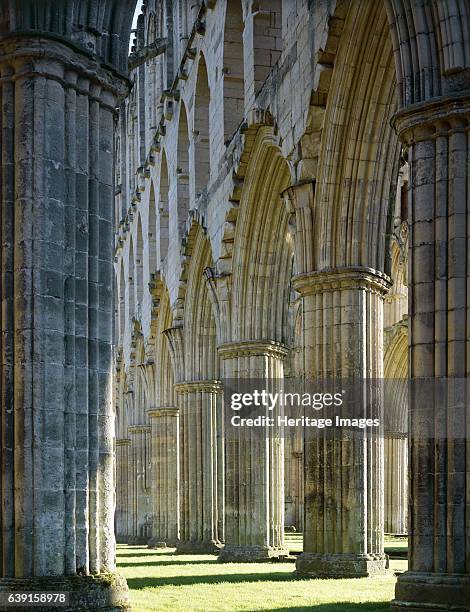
[[218, 125, 293, 562]]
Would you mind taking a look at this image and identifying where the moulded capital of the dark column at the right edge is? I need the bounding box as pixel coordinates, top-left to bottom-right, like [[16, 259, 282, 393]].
[[391, 90, 470, 145]]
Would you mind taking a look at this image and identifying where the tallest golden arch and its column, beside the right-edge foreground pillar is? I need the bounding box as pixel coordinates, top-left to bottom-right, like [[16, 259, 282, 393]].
[[296, 2, 400, 577]]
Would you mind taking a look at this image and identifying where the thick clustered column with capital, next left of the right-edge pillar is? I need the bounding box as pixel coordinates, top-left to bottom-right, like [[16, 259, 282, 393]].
[[294, 268, 389, 577]]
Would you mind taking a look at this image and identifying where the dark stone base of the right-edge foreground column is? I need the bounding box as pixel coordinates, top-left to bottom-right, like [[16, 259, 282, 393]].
[[391, 572, 470, 612]]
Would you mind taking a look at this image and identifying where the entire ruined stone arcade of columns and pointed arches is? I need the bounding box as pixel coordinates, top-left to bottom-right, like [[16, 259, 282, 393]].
[[0, 0, 470, 611]]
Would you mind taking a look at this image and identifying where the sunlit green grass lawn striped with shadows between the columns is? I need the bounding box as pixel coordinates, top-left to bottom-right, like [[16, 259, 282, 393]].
[[117, 534, 406, 612]]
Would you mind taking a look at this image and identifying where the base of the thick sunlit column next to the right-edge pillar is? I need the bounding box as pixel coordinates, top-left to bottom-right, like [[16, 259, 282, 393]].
[[295, 552, 388, 578]]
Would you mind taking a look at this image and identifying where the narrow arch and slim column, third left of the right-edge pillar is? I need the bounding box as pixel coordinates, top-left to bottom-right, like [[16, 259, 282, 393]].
[[175, 219, 224, 553]]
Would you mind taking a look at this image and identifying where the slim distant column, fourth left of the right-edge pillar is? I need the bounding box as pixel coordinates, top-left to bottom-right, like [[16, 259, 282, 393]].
[[148, 406, 180, 548]]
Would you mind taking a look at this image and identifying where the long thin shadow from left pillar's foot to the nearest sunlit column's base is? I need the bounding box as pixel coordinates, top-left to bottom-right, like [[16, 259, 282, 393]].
[[127, 572, 310, 589]]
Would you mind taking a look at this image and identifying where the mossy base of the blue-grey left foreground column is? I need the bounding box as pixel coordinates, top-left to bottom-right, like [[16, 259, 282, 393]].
[[0, 573, 131, 612]]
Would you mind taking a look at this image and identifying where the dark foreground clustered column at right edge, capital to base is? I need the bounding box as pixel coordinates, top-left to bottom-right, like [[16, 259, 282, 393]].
[[392, 94, 470, 611]]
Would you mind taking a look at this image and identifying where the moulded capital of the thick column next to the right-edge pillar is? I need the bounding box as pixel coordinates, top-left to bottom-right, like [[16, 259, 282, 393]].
[[292, 266, 392, 295]]
